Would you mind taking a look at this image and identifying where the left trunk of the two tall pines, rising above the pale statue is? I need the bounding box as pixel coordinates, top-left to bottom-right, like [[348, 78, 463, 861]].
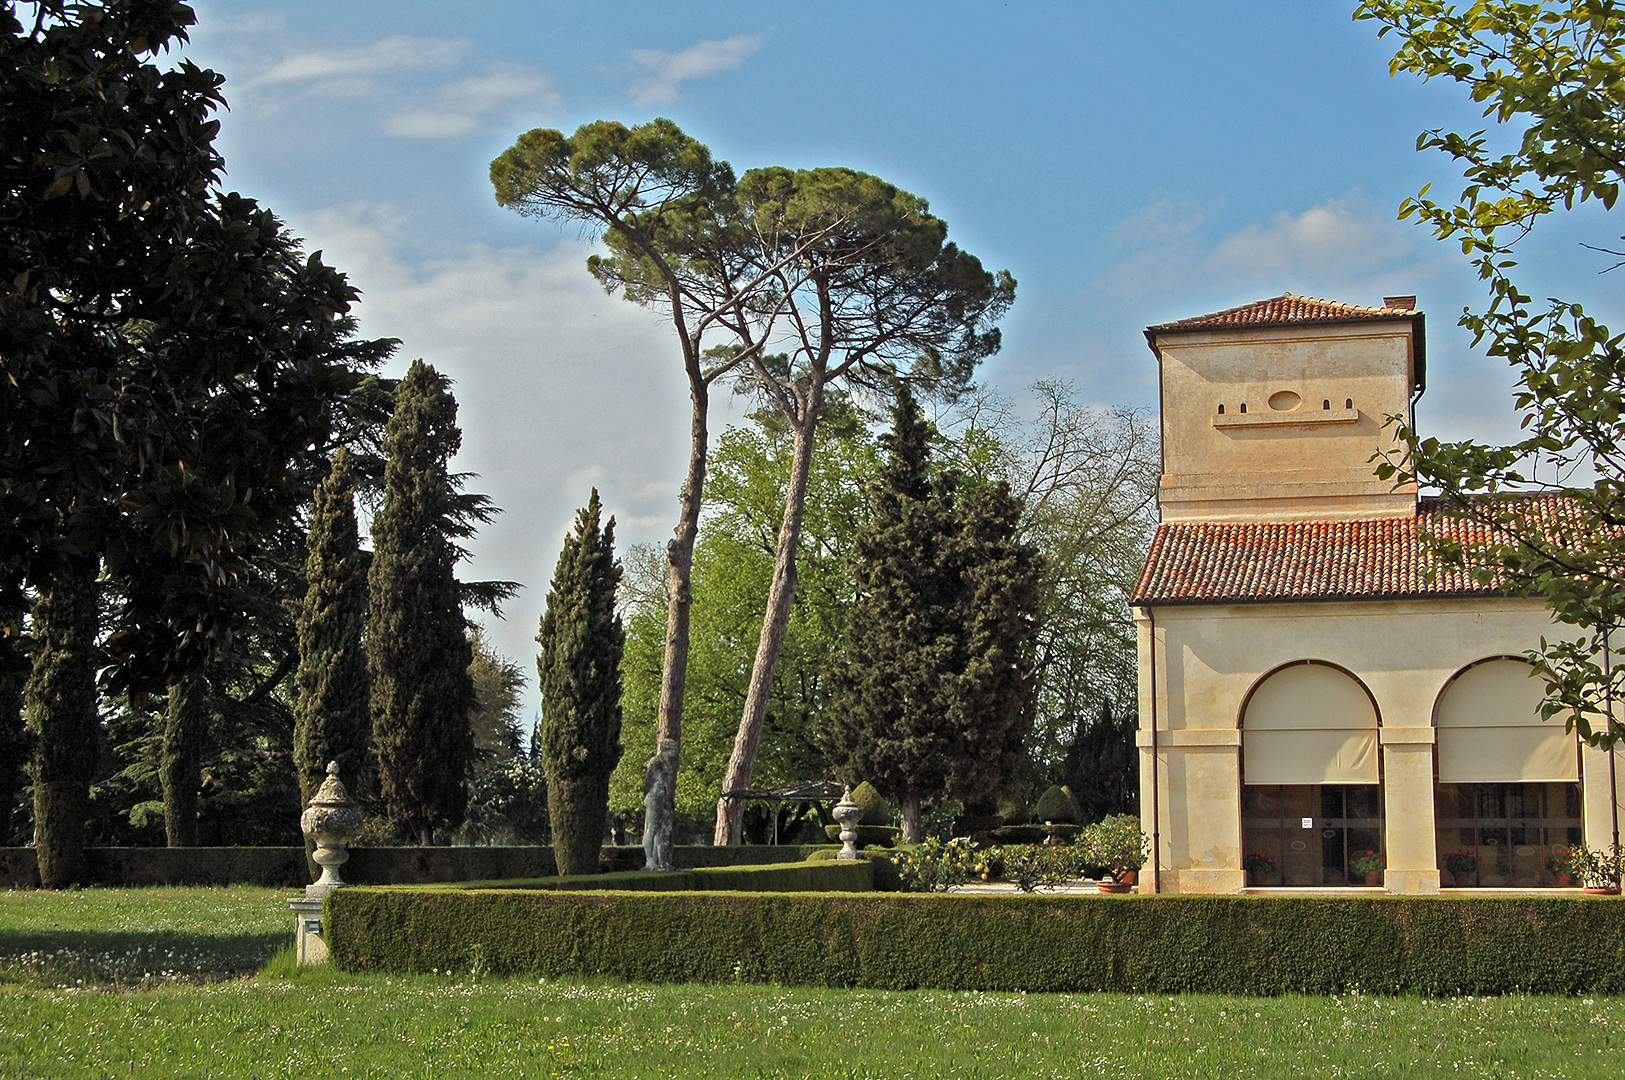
[[655, 376, 710, 799]]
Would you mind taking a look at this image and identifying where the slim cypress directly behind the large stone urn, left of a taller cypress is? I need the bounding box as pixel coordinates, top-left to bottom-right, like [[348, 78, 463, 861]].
[[294, 450, 372, 804]]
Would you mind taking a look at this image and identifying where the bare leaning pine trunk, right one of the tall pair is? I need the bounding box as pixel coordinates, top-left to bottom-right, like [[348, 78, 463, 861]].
[[712, 380, 824, 845]]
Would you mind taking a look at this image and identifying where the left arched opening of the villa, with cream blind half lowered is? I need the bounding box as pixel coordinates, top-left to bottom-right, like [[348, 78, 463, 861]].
[[1242, 661, 1383, 885]]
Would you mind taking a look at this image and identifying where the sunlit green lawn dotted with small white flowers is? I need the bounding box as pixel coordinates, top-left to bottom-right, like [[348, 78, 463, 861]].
[[0, 888, 1625, 1080]]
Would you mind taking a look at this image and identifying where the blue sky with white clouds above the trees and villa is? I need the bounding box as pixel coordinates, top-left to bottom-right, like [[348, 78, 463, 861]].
[[185, 0, 1614, 714]]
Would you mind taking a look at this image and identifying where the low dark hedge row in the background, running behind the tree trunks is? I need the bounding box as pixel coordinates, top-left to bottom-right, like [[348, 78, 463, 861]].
[[0, 845, 824, 888]]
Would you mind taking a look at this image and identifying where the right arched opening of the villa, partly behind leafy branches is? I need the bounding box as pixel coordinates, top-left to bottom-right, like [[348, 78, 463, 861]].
[[1433, 656, 1581, 888]]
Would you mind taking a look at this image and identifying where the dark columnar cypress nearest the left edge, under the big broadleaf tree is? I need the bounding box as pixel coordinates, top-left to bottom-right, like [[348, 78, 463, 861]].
[[23, 560, 99, 888]]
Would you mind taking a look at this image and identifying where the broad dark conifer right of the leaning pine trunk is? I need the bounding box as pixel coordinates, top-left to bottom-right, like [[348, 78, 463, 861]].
[[826, 387, 1038, 843]]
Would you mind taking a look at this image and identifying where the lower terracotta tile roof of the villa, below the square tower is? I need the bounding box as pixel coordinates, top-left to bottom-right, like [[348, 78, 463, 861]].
[[1129, 495, 1573, 606]]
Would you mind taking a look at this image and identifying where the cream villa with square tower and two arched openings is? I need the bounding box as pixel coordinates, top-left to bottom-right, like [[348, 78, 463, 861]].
[[1131, 294, 1625, 893]]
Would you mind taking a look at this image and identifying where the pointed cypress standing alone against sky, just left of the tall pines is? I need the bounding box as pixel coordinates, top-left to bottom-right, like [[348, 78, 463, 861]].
[[536, 489, 626, 874]]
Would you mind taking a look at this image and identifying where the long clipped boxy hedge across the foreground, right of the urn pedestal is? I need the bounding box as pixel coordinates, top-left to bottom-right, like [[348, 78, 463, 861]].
[[327, 888, 1625, 994]]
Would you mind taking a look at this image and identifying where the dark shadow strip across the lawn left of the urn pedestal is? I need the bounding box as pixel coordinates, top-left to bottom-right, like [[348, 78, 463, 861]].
[[0, 931, 293, 986]]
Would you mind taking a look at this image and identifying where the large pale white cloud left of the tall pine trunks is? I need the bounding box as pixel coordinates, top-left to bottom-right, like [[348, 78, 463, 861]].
[[289, 205, 689, 704]]
